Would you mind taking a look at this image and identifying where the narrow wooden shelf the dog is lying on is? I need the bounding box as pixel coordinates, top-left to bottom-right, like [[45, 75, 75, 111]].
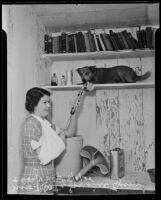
[[43, 82, 155, 91]]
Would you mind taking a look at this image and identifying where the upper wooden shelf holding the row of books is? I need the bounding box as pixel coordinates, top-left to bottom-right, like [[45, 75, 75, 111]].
[[42, 49, 155, 62]]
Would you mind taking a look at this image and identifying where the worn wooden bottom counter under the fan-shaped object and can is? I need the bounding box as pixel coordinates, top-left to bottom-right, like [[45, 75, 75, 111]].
[[56, 172, 155, 191]]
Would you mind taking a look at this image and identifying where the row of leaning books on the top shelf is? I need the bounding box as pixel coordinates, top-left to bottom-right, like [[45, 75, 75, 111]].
[[44, 27, 156, 54]]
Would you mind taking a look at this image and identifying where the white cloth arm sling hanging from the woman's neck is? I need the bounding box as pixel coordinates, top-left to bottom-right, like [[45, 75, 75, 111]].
[[31, 115, 65, 165]]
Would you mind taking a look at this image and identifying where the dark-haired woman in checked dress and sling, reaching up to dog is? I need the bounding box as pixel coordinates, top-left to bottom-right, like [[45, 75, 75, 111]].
[[18, 84, 93, 194]]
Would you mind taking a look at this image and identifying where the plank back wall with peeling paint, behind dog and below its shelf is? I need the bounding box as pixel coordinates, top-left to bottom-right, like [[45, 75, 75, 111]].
[[52, 57, 155, 172]]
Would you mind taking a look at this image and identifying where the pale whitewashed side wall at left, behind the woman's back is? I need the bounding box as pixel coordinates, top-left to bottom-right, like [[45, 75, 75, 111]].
[[3, 5, 47, 194]]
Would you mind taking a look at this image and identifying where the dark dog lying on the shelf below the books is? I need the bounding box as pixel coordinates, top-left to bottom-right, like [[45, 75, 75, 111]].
[[77, 65, 150, 84]]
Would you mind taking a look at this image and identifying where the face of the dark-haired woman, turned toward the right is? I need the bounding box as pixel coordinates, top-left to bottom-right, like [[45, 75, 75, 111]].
[[34, 95, 51, 118]]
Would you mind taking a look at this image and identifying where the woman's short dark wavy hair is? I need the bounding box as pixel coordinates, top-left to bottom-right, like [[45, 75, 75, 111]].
[[25, 87, 50, 113]]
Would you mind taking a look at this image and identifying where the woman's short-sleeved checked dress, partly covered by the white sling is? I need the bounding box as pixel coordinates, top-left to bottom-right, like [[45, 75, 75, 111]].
[[18, 116, 55, 194]]
